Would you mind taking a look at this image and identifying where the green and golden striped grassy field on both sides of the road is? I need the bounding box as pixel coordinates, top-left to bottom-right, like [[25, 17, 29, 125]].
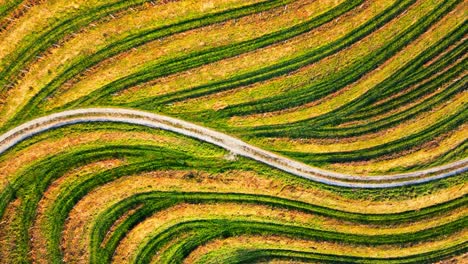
[[0, 0, 468, 263]]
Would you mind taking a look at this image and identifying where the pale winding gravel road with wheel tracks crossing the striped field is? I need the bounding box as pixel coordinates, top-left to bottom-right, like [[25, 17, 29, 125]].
[[0, 108, 468, 188]]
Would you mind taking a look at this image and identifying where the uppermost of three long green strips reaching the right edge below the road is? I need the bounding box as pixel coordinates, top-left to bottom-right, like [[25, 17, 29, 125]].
[[88, 191, 468, 263]]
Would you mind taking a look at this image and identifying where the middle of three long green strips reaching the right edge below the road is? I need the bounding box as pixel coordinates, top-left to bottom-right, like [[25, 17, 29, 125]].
[[135, 218, 467, 263]]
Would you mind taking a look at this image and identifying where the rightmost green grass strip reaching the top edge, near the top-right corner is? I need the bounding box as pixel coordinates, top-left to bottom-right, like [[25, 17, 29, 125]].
[[222, 0, 460, 118]]
